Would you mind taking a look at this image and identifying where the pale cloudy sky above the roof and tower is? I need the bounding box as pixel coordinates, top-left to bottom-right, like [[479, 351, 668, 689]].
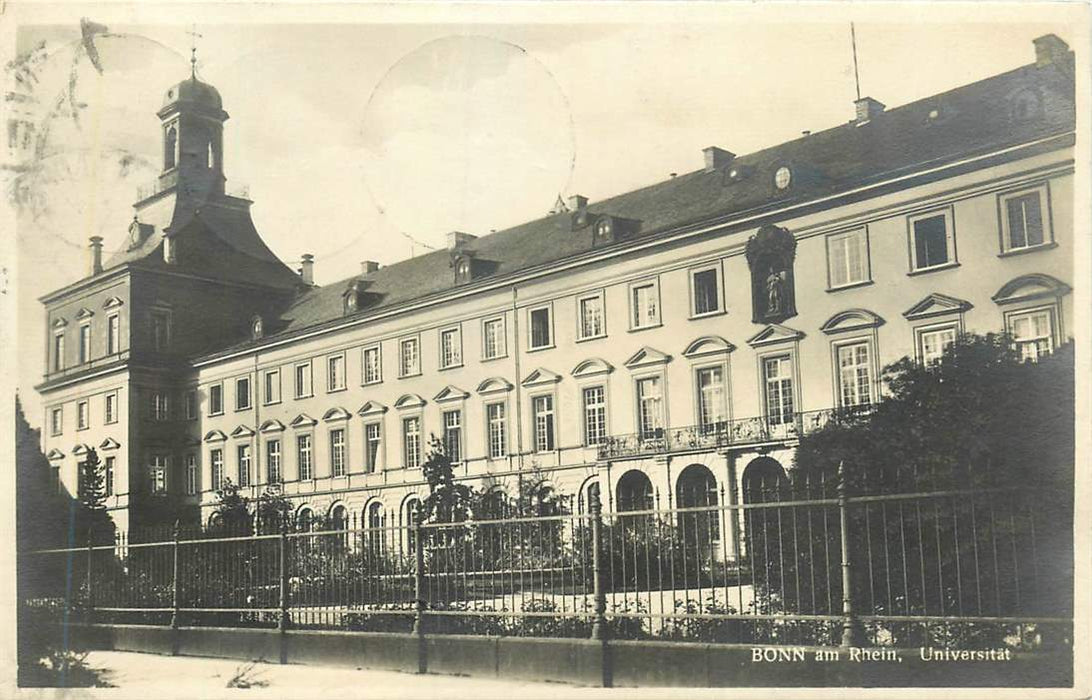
[[6, 4, 1080, 425]]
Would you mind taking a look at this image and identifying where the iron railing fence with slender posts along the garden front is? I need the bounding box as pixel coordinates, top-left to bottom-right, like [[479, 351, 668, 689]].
[[20, 471, 1072, 649]]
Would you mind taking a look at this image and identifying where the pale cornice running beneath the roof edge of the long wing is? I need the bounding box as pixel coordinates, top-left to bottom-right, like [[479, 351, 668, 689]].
[[185, 130, 1076, 368]]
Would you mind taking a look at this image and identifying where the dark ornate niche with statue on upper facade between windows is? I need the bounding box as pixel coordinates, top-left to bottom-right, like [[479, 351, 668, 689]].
[[746, 224, 796, 323]]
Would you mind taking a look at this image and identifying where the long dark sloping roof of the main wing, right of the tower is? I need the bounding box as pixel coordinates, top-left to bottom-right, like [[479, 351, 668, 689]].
[[196, 54, 1076, 360]]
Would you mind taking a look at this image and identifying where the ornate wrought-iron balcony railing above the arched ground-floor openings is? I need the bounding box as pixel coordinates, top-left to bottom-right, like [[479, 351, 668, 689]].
[[598, 406, 871, 460]]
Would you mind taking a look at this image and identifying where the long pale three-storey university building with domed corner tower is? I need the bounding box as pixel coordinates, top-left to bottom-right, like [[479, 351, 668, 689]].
[[38, 35, 1075, 546]]
